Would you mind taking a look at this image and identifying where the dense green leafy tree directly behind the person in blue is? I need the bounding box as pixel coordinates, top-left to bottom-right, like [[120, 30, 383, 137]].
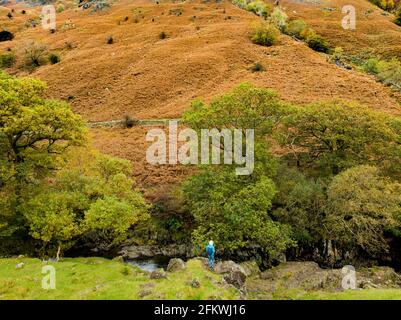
[[183, 167, 294, 256]]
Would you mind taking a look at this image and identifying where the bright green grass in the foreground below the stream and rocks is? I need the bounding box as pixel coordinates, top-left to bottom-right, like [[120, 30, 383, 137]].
[[0, 258, 401, 300]]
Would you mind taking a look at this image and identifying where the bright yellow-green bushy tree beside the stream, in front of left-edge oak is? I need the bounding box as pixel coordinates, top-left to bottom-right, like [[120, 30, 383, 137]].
[[21, 150, 149, 253]]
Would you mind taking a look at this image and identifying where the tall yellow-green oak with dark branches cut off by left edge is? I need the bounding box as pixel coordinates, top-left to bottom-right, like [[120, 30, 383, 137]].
[[0, 71, 86, 239]]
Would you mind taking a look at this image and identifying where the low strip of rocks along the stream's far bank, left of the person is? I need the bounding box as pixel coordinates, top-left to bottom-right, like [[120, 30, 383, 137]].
[[119, 244, 193, 259]]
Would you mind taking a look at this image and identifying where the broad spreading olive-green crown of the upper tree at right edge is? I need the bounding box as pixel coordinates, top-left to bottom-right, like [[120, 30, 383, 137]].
[[277, 100, 401, 175]]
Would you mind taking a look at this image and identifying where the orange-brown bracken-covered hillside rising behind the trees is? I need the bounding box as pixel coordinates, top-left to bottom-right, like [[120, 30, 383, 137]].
[[0, 0, 401, 186]]
